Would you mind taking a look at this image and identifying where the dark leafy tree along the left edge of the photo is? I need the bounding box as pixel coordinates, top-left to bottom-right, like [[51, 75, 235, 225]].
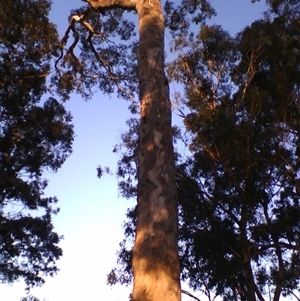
[[0, 0, 73, 285]]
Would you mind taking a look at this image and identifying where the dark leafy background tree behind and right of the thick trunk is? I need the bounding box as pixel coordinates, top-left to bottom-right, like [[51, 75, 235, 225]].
[[108, 1, 300, 300]]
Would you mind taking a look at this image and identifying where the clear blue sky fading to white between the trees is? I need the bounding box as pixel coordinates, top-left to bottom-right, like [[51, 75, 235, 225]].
[[0, 0, 265, 301]]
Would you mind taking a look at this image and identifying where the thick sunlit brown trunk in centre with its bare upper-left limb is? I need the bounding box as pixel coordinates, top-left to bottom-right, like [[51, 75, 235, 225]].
[[87, 0, 181, 301]]
